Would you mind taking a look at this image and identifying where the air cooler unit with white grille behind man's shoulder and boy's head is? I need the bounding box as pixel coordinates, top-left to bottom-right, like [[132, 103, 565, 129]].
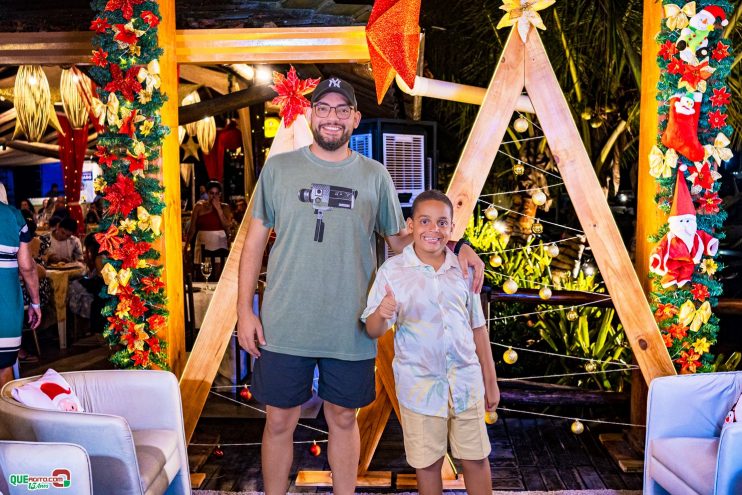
[[350, 119, 437, 211]]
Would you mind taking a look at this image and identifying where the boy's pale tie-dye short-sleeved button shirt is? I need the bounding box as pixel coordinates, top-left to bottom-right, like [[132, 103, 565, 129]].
[[361, 244, 486, 418]]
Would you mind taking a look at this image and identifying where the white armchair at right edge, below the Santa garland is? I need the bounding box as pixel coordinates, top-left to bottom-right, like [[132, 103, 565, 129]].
[[644, 372, 742, 495]]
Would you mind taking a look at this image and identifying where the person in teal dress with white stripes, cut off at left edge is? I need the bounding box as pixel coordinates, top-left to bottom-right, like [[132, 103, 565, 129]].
[[0, 204, 41, 388]]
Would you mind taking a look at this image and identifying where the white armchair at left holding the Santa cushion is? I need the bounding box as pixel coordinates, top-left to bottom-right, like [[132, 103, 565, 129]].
[[0, 370, 191, 495]]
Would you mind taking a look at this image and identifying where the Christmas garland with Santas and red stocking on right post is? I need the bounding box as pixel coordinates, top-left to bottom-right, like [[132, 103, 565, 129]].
[[650, 0, 733, 373]]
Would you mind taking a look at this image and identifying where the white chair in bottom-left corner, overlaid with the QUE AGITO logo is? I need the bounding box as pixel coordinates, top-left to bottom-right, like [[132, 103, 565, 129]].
[[0, 441, 93, 495]]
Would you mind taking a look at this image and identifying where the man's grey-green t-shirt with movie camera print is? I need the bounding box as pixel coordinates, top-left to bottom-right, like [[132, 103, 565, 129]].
[[252, 147, 404, 361]]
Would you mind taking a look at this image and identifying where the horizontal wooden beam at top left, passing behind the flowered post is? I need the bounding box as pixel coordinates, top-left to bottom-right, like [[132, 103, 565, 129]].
[[0, 26, 369, 66]]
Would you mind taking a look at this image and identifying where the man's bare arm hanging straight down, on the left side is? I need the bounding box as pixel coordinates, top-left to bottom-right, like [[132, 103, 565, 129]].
[[237, 217, 271, 357]]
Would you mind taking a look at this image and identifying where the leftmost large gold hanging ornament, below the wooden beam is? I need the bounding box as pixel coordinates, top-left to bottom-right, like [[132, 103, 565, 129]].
[[13, 65, 64, 142]]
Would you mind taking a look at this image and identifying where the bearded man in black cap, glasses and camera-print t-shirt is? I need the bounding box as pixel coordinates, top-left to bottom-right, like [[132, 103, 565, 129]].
[[237, 78, 483, 495]]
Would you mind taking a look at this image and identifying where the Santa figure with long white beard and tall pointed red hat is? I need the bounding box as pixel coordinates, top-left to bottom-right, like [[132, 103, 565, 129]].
[[649, 171, 719, 288]]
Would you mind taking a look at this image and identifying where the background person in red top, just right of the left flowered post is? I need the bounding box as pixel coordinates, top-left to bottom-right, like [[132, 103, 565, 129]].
[[184, 181, 232, 263]]
